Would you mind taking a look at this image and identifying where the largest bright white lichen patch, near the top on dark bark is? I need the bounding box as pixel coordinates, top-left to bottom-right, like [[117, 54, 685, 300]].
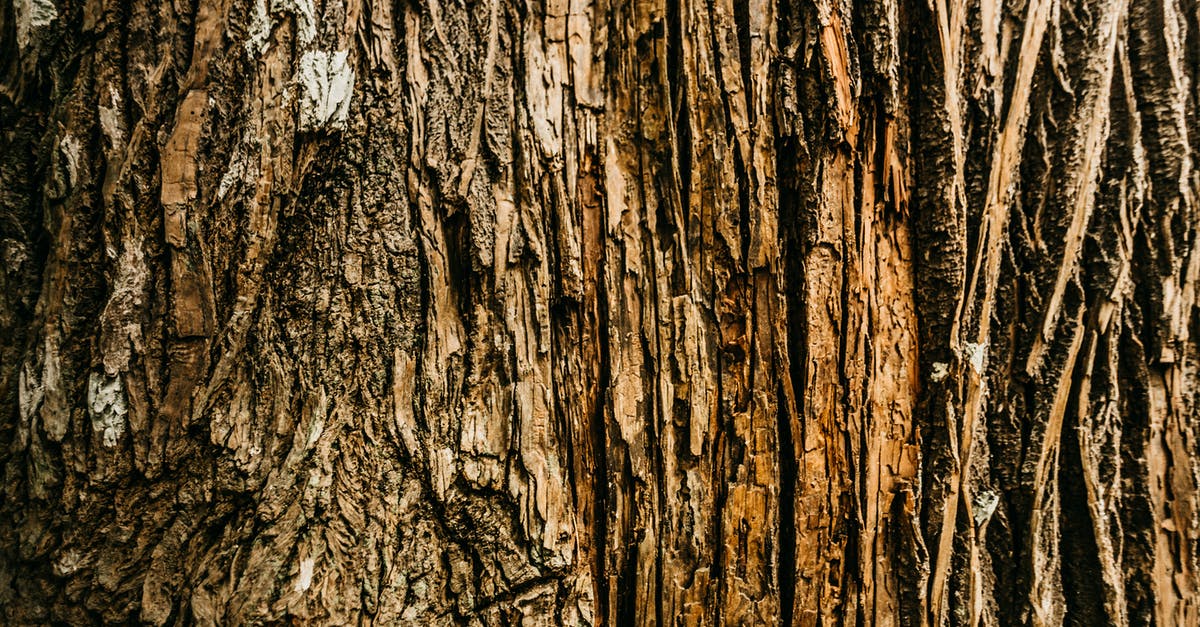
[[296, 50, 354, 131]]
